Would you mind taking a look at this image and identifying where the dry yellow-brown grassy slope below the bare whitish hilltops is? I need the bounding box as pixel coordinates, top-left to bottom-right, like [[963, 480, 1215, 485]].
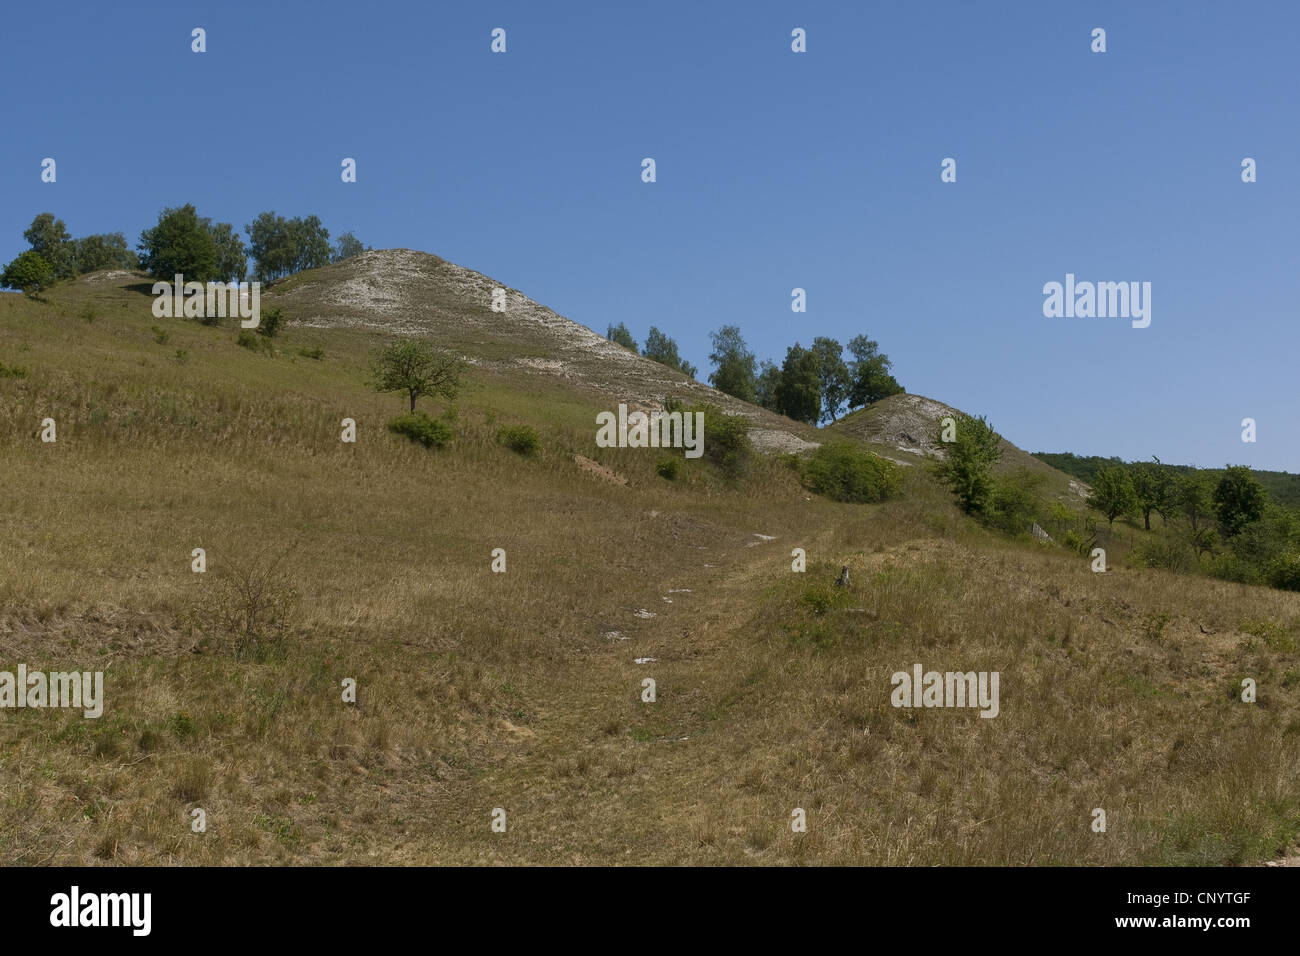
[[0, 270, 1300, 864]]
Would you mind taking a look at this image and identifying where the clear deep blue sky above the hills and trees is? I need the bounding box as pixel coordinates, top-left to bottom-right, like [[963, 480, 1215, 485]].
[[0, 0, 1300, 471]]
